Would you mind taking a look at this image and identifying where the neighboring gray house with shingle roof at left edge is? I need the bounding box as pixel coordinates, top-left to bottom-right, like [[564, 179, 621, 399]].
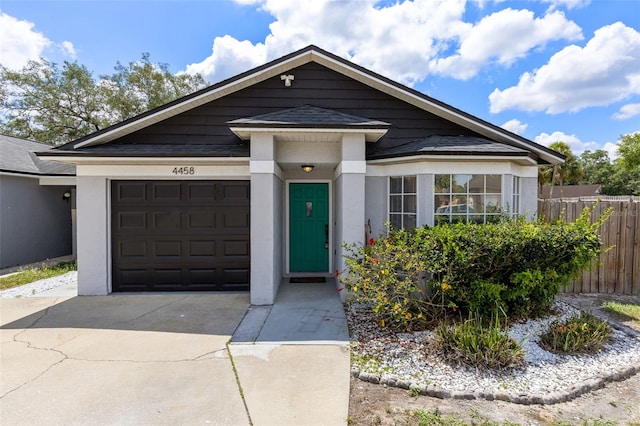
[[0, 135, 75, 269]]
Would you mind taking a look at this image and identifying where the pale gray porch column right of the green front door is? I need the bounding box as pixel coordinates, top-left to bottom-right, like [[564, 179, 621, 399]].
[[334, 134, 367, 294]]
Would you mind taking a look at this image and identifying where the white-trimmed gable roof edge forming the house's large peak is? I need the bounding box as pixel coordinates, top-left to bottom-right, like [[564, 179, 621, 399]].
[[44, 45, 565, 164]]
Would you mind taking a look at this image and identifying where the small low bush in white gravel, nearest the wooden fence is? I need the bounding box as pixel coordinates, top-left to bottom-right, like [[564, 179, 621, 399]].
[[540, 311, 611, 353]]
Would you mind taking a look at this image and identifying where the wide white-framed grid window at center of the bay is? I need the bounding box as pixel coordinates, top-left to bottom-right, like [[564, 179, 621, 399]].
[[434, 174, 502, 223]]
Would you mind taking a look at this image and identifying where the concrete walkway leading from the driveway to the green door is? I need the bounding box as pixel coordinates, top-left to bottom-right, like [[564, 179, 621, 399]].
[[229, 279, 350, 426]]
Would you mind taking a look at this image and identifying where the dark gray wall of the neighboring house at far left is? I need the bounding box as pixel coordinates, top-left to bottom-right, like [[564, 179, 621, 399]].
[[0, 175, 73, 268]]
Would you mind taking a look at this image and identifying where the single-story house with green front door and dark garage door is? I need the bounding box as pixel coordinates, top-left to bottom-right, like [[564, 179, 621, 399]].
[[40, 46, 564, 304]]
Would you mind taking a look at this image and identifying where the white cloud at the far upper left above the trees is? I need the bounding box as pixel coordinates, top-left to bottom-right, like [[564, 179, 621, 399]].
[[0, 12, 51, 70]]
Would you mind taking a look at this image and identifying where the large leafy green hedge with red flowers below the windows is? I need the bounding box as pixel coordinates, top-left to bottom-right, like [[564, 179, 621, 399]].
[[340, 203, 608, 331]]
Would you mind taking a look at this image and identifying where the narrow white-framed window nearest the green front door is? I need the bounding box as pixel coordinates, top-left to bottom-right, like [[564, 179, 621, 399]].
[[389, 176, 418, 229]]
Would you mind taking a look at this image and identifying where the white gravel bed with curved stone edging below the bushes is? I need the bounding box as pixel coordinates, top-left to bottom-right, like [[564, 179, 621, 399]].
[[347, 302, 640, 403]]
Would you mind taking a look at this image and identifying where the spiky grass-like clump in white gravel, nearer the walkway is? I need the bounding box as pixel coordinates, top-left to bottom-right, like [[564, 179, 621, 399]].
[[437, 316, 524, 369]]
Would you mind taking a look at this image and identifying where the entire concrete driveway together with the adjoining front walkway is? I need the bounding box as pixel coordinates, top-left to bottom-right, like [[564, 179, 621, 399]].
[[0, 282, 349, 426]]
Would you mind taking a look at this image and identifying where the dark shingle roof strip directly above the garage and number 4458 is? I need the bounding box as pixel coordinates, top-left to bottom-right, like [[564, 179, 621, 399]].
[[47, 143, 249, 157]]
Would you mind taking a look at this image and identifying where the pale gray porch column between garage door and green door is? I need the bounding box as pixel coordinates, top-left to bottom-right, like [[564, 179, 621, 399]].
[[249, 134, 282, 305]]
